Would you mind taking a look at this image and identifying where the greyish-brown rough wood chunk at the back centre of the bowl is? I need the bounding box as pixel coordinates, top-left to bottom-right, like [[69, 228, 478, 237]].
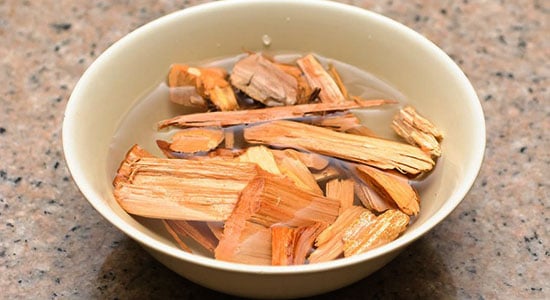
[[230, 53, 298, 106]]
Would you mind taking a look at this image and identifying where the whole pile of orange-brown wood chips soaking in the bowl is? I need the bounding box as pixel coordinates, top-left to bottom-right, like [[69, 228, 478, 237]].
[[113, 53, 442, 265]]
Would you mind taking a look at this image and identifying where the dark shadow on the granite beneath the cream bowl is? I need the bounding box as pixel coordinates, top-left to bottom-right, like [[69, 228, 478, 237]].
[[92, 237, 457, 300]]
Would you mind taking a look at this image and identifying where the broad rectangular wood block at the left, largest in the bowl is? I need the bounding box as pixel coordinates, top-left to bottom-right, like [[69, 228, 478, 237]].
[[114, 147, 258, 221]]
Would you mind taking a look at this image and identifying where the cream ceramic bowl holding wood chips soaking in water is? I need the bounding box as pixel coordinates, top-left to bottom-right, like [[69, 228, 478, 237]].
[[63, 0, 485, 298]]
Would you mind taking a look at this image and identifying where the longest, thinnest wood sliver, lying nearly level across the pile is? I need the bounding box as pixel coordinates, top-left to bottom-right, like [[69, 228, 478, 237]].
[[157, 99, 396, 129]]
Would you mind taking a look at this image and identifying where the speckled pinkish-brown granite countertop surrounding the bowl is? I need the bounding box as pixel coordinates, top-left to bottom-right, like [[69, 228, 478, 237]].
[[0, 0, 550, 299]]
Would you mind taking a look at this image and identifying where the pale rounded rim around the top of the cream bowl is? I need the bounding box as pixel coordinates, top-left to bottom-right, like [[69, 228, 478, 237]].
[[62, 0, 486, 274]]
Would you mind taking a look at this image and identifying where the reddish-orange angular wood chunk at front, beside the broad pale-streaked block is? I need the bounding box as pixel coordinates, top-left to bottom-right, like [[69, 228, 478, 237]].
[[215, 171, 339, 264]]
